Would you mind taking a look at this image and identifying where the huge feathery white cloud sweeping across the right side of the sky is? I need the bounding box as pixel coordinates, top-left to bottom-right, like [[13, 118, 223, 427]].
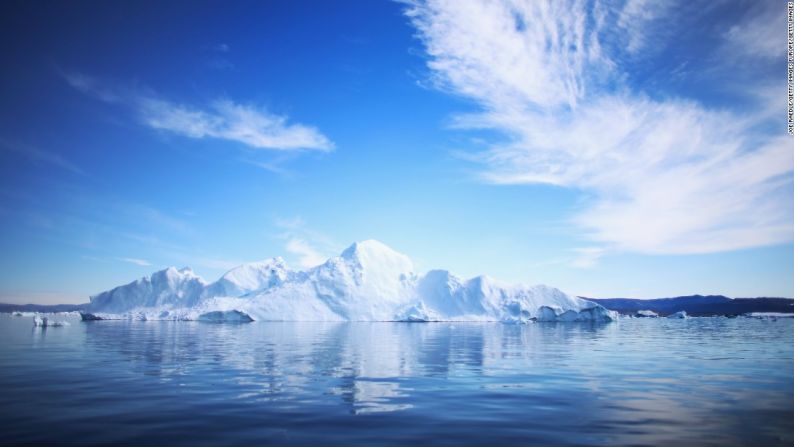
[[406, 0, 794, 260]]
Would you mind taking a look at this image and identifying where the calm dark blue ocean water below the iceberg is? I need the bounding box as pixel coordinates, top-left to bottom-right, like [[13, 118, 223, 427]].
[[0, 315, 794, 446]]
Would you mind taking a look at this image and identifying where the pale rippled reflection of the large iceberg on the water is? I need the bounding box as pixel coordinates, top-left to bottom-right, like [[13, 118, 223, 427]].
[[84, 322, 609, 414]]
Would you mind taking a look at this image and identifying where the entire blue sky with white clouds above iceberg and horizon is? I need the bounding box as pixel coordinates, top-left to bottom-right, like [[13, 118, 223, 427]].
[[0, 0, 794, 303]]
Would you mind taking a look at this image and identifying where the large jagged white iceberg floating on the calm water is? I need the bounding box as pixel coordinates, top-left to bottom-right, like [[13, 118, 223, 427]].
[[82, 240, 617, 322]]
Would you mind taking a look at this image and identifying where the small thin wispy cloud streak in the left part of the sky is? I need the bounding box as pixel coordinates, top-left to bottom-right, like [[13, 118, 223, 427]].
[[64, 73, 334, 151]]
